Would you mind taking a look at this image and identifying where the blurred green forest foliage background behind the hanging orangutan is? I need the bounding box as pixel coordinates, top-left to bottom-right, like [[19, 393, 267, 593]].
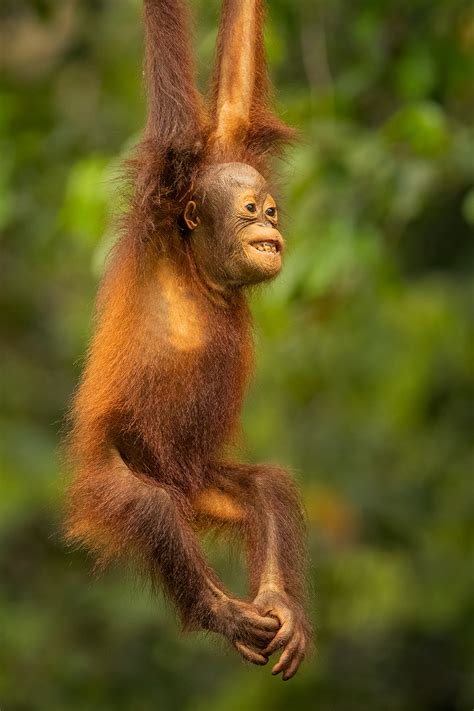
[[0, 0, 474, 711]]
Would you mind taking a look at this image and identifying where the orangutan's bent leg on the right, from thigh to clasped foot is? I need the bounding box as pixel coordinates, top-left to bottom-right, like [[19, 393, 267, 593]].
[[194, 464, 310, 680]]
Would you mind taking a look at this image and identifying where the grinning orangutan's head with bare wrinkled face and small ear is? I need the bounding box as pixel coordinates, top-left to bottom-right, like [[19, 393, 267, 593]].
[[183, 163, 284, 288]]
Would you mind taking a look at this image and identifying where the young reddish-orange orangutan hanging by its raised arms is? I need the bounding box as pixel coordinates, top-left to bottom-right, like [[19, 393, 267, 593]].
[[68, 0, 309, 679]]
